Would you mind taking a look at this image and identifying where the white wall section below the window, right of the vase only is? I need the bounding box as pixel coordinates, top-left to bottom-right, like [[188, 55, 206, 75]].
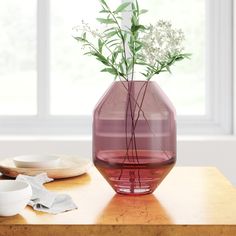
[[177, 135, 236, 186]]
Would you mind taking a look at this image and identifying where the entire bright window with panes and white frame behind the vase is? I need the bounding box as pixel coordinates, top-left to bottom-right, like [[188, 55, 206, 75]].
[[0, 0, 233, 134]]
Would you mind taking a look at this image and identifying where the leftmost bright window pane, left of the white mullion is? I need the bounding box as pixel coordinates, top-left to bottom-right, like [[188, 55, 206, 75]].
[[0, 0, 37, 116]]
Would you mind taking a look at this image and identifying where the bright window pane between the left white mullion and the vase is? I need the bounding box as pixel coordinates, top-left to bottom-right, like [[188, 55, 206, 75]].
[[50, 0, 120, 116]]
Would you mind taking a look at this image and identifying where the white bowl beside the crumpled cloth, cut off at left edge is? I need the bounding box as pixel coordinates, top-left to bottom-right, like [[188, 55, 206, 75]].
[[0, 180, 32, 216]]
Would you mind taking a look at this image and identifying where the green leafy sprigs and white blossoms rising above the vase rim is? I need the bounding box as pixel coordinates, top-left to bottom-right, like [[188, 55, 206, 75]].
[[74, 0, 190, 81]]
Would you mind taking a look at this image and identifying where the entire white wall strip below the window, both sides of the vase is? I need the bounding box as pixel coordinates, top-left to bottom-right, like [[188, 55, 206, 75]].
[[0, 136, 236, 186]]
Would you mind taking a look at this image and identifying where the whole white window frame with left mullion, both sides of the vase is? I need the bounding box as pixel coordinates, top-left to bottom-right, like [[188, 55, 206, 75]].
[[0, 0, 233, 135]]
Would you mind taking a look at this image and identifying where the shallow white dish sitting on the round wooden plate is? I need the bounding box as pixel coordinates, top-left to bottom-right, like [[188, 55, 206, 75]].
[[13, 155, 60, 168]]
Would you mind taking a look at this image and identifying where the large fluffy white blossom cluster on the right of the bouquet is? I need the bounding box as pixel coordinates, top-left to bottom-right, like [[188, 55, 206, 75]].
[[141, 20, 185, 65]]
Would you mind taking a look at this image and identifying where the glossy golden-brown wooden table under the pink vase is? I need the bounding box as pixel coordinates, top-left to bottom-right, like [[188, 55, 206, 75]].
[[0, 167, 236, 236]]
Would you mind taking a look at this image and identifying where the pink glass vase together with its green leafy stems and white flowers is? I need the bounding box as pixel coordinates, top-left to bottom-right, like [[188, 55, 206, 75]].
[[74, 0, 190, 195]]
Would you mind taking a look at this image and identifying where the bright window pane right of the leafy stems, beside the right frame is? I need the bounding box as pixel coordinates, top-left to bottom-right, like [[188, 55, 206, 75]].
[[143, 0, 206, 116]]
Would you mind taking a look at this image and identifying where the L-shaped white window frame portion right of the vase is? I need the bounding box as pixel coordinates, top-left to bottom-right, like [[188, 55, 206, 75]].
[[178, 0, 233, 135]]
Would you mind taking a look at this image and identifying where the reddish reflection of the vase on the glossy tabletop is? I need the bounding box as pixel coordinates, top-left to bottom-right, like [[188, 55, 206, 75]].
[[96, 194, 173, 224]]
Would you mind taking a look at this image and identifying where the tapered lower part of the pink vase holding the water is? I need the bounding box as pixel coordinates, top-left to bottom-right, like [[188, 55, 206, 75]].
[[94, 150, 175, 195]]
